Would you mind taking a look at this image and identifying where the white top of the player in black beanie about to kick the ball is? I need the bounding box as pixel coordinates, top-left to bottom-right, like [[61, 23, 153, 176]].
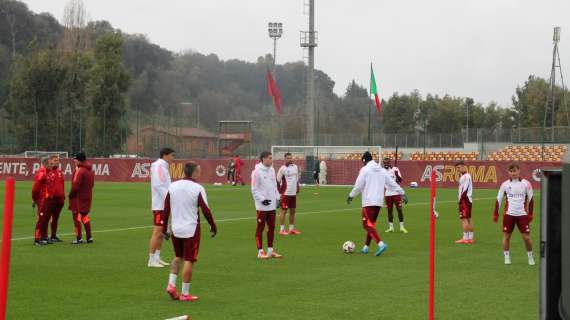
[[349, 161, 405, 208]]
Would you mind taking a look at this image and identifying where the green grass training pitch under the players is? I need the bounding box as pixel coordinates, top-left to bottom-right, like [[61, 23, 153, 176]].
[[0, 182, 538, 320]]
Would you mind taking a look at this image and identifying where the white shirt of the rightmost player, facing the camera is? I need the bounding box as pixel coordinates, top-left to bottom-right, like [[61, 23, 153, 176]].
[[497, 179, 533, 217]]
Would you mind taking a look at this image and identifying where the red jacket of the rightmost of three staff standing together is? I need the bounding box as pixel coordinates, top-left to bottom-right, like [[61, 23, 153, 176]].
[[69, 162, 95, 213]]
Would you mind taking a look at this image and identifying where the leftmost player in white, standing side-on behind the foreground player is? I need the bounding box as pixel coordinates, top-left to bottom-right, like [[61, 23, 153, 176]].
[[147, 148, 174, 268]]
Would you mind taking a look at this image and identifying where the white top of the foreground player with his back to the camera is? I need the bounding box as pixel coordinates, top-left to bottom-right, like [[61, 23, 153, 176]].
[[168, 179, 211, 238]]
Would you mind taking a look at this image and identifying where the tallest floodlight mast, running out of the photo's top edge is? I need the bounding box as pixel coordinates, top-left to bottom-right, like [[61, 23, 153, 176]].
[[301, 0, 317, 145]]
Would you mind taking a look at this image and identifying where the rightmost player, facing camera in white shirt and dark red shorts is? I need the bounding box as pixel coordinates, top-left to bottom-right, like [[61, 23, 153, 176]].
[[493, 163, 534, 266]]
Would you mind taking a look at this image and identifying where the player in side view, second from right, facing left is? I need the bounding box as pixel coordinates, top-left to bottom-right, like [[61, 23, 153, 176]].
[[455, 161, 475, 244]]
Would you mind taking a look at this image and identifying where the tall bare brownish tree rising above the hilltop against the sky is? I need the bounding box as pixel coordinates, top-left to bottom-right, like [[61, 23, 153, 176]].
[[62, 0, 89, 52]]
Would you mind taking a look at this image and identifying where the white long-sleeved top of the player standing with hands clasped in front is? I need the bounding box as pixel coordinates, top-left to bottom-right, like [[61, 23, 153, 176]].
[[251, 163, 279, 211]]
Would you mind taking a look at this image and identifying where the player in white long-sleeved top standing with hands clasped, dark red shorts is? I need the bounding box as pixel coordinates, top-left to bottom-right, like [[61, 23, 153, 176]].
[[251, 151, 282, 259]]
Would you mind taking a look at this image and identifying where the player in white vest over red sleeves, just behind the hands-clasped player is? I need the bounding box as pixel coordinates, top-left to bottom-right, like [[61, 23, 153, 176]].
[[277, 152, 301, 236]]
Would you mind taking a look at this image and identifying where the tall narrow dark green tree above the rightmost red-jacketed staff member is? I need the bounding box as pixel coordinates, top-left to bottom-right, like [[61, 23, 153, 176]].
[[86, 32, 130, 156]]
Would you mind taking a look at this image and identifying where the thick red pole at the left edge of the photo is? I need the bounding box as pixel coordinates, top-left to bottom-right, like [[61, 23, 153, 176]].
[[0, 178, 15, 320]]
